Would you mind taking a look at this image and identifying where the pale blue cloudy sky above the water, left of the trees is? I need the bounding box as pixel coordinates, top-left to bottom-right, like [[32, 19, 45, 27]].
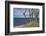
[[13, 8, 31, 18]]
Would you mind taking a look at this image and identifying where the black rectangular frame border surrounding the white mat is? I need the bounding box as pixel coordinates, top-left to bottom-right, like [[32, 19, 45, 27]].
[[5, 1, 45, 35]]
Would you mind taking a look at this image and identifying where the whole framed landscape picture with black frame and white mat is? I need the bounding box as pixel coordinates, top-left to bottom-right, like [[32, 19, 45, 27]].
[[5, 1, 45, 35]]
